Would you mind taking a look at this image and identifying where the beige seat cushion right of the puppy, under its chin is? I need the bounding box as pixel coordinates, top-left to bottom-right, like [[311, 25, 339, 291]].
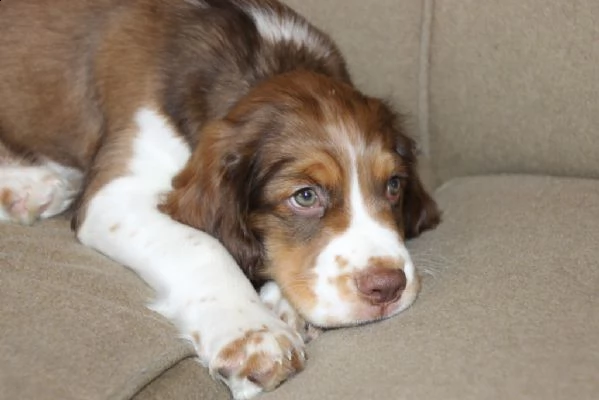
[[263, 176, 599, 400]]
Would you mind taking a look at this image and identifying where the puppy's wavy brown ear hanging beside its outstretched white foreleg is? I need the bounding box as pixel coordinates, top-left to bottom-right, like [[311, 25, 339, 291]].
[[159, 121, 263, 279]]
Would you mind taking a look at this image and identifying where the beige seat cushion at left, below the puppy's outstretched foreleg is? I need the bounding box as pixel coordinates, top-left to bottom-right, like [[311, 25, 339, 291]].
[[0, 219, 227, 400]]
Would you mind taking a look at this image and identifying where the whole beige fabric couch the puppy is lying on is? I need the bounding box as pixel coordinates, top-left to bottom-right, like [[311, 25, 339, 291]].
[[0, 0, 599, 400]]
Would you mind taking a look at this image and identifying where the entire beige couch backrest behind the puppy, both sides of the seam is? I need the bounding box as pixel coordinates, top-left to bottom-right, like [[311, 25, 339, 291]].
[[287, 0, 599, 182]]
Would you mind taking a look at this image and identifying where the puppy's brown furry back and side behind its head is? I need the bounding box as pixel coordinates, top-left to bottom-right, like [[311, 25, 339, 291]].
[[0, 0, 349, 170]]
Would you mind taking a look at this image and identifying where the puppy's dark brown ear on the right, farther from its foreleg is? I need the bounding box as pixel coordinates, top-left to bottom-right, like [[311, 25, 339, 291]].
[[397, 133, 441, 238]]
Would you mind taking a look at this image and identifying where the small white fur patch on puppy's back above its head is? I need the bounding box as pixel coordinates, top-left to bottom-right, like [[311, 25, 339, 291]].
[[247, 7, 330, 57]]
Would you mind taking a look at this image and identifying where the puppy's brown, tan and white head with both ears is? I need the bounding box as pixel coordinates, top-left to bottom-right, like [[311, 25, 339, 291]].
[[163, 72, 439, 327]]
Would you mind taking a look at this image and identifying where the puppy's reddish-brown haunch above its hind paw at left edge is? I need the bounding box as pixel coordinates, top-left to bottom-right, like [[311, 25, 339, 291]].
[[0, 0, 119, 168]]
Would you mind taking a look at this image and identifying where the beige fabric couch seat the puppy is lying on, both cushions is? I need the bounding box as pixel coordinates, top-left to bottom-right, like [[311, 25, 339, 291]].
[[0, 176, 599, 400]]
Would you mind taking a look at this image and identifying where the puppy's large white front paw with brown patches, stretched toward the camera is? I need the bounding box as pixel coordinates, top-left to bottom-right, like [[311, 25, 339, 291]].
[[179, 298, 306, 400]]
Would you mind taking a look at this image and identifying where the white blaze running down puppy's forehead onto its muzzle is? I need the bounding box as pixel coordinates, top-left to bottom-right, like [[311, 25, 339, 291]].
[[309, 145, 415, 326]]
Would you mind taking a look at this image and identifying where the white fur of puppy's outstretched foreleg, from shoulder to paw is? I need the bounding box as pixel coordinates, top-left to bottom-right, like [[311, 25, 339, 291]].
[[78, 109, 303, 399]]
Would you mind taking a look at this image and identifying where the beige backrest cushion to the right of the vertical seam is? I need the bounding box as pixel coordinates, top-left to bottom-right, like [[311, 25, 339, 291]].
[[430, 0, 599, 180]]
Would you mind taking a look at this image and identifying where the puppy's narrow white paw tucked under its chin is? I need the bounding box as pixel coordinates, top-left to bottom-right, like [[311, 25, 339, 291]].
[[260, 281, 322, 343]]
